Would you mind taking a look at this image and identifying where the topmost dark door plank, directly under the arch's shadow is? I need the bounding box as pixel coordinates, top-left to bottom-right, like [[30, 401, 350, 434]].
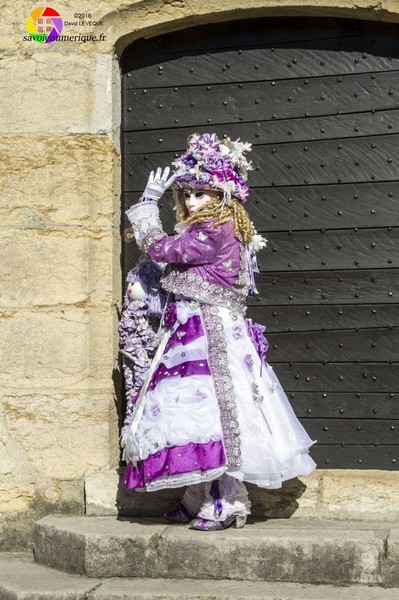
[[124, 48, 399, 90]]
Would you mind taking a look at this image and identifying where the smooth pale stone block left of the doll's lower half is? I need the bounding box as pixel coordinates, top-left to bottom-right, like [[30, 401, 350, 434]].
[[0, 308, 117, 393]]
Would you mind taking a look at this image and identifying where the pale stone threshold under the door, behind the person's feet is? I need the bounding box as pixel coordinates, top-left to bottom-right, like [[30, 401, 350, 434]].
[[85, 468, 398, 522]]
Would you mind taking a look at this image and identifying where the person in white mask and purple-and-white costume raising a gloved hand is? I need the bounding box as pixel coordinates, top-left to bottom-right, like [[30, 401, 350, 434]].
[[122, 134, 316, 531]]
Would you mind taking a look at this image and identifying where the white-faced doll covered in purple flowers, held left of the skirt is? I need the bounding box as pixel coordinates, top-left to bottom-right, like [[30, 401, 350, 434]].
[[118, 258, 166, 436]]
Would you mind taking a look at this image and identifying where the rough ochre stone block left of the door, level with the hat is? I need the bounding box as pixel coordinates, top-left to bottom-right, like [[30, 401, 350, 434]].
[[0, 134, 120, 230]]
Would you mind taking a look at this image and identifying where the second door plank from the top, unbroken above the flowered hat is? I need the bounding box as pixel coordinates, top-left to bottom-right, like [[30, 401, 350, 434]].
[[122, 71, 399, 130]]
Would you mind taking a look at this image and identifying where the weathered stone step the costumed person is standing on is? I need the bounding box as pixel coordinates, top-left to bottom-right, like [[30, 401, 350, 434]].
[[34, 515, 399, 587]]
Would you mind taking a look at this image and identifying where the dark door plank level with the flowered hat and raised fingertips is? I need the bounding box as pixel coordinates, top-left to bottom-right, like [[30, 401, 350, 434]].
[[124, 134, 399, 191]]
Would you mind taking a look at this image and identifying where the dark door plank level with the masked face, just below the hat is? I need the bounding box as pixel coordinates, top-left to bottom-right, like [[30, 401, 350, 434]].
[[122, 183, 399, 230]]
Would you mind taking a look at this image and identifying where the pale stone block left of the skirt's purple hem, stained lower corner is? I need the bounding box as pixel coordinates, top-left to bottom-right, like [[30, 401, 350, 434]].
[[2, 393, 115, 478]]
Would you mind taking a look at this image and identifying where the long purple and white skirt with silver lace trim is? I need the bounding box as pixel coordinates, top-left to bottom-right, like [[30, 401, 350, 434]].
[[122, 298, 316, 491]]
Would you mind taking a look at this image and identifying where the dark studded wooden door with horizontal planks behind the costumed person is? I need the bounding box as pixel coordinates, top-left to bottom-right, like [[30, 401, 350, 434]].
[[121, 18, 399, 469]]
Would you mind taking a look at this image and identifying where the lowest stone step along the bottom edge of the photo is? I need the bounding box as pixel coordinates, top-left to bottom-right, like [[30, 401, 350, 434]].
[[0, 553, 399, 600]]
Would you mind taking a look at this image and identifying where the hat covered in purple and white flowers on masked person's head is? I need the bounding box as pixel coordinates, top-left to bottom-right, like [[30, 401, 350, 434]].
[[172, 133, 253, 202]]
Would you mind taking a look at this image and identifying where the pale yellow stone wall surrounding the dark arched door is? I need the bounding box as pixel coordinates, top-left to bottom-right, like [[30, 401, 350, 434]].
[[0, 0, 399, 549]]
